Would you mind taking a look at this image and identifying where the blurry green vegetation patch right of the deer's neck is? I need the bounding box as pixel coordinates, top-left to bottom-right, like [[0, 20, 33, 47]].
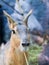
[[28, 44, 42, 65]]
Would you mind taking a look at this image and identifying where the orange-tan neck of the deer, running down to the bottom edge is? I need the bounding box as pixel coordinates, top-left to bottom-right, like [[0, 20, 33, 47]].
[[10, 34, 28, 65]]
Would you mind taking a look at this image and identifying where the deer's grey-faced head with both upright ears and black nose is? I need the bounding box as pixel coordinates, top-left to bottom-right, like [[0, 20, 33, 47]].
[[4, 10, 32, 49]]
